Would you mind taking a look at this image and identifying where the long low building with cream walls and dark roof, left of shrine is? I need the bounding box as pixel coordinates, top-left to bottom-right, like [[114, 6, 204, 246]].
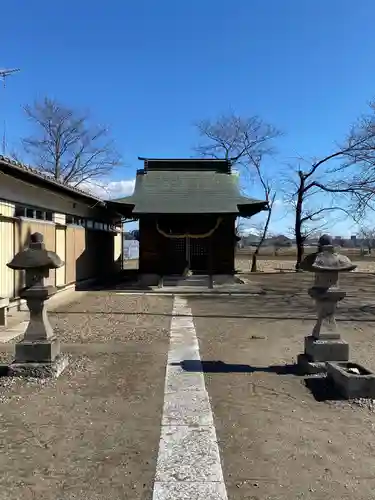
[[0, 174, 122, 298]]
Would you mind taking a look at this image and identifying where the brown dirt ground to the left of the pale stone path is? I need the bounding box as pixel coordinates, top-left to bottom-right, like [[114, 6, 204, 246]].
[[0, 293, 172, 500]]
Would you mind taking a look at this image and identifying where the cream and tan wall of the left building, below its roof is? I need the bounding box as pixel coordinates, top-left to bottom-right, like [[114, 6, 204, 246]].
[[0, 196, 123, 298]]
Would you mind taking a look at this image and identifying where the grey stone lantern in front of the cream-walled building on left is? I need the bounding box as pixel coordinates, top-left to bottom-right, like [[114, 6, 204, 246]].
[[7, 233, 68, 377]]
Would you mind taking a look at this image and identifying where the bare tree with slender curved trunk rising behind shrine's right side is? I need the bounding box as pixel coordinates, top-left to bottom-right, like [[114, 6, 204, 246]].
[[195, 113, 282, 272]]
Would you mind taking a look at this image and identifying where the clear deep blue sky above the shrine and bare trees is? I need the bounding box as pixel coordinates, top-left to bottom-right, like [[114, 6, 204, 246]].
[[0, 0, 375, 234]]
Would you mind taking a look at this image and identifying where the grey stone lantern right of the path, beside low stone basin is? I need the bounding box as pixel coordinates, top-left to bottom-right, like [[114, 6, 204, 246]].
[[298, 235, 357, 373]]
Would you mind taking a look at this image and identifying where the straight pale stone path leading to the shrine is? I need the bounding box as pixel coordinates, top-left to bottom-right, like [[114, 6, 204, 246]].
[[153, 296, 228, 500]]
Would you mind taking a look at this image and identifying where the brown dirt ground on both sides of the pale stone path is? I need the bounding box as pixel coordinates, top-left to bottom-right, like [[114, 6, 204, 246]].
[[0, 273, 375, 500]]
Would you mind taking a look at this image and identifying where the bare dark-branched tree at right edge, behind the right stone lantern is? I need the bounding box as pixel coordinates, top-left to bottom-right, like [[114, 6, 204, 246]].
[[284, 98, 375, 270]]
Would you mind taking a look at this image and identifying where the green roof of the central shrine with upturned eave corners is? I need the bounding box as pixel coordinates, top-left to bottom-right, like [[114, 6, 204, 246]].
[[108, 169, 267, 216]]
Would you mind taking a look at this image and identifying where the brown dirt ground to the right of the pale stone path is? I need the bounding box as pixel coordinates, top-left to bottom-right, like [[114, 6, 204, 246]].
[[189, 275, 375, 500]]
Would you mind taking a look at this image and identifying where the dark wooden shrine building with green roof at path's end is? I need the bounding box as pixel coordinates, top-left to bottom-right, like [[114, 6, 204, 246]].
[[107, 158, 267, 276]]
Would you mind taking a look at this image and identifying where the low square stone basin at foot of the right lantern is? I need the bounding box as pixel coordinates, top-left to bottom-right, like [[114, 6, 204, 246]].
[[327, 363, 375, 399]]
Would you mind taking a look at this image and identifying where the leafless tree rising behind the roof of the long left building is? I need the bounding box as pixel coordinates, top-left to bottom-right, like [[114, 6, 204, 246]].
[[22, 98, 120, 187]]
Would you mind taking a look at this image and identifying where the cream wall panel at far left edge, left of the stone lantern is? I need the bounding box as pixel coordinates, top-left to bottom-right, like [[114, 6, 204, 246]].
[[0, 220, 15, 298]]
